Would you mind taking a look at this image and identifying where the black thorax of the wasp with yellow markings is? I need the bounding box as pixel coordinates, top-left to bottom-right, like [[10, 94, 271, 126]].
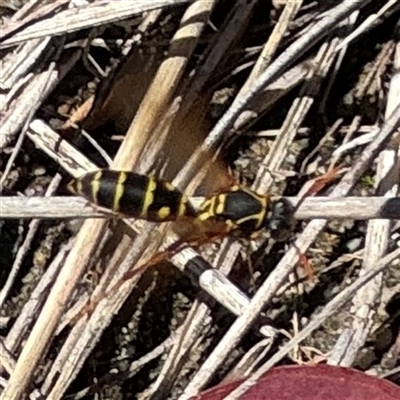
[[198, 186, 269, 236]]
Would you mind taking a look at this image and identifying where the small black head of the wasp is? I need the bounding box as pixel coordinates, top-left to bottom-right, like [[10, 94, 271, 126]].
[[266, 198, 295, 241]]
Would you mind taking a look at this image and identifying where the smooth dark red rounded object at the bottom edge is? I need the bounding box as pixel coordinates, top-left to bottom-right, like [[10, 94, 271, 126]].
[[191, 365, 400, 400]]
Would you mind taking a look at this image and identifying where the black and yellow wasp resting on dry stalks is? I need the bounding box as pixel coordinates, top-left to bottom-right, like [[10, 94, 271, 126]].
[[68, 169, 293, 241]]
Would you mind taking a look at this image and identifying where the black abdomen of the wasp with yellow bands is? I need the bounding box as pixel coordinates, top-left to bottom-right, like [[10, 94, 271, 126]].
[[68, 169, 197, 222]]
